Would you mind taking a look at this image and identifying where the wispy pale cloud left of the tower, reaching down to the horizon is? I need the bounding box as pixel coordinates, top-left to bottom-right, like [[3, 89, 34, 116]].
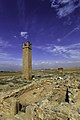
[[0, 37, 21, 70]]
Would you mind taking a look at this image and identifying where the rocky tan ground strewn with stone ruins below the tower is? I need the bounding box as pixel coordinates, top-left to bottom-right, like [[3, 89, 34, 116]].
[[0, 69, 80, 120]]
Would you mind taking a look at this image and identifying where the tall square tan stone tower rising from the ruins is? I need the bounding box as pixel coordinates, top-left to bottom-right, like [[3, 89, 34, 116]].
[[22, 41, 32, 80]]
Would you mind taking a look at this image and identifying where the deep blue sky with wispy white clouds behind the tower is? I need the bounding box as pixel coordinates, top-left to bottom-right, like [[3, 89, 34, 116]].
[[0, 0, 80, 70]]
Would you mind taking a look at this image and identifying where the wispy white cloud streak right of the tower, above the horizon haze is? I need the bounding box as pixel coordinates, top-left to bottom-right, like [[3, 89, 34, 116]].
[[36, 43, 80, 61]]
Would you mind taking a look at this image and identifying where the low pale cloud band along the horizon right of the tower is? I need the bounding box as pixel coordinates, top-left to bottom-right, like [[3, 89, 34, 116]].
[[33, 60, 80, 69]]
